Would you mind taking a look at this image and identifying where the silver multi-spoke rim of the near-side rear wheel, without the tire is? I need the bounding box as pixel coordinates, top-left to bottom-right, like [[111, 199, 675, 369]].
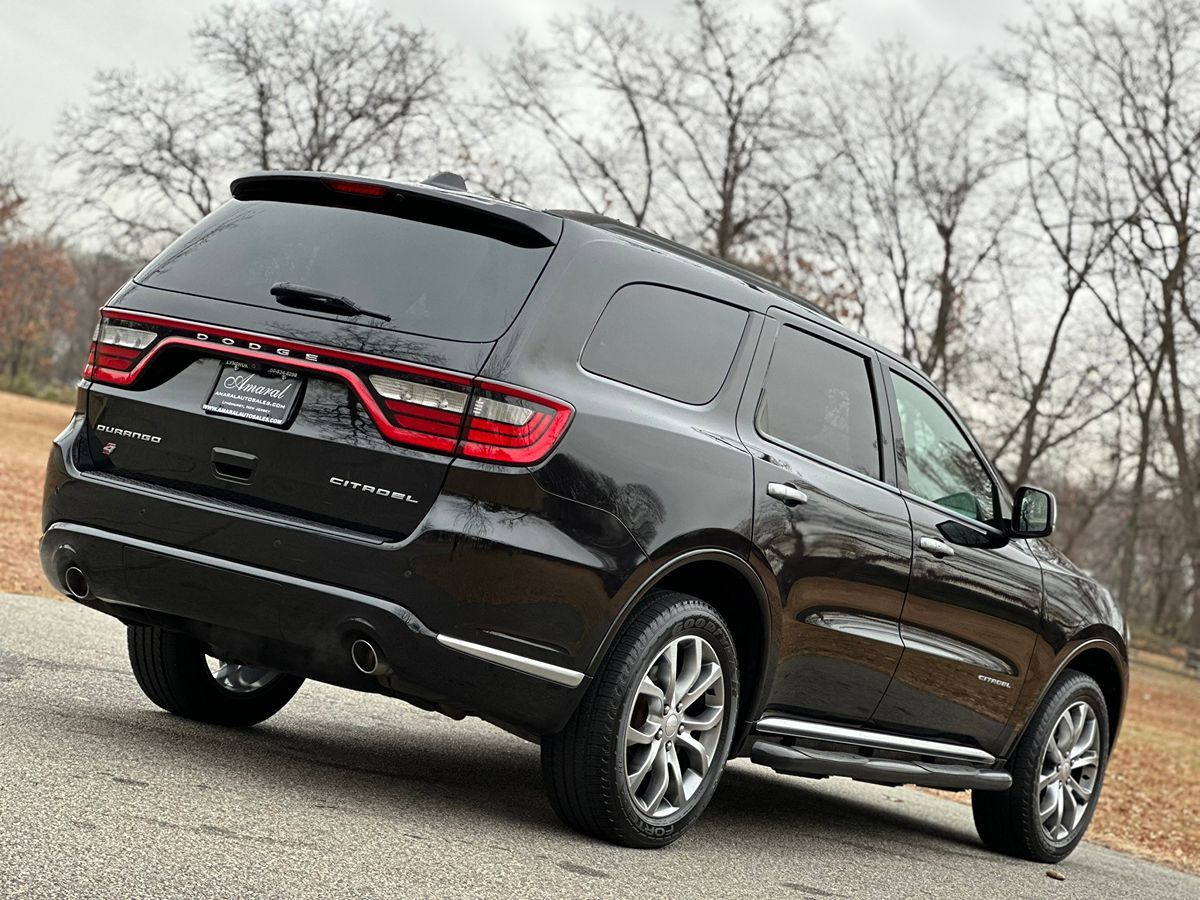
[[625, 635, 725, 818]]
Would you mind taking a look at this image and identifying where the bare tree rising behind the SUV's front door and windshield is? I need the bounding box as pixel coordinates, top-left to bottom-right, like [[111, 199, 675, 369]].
[[812, 43, 1020, 383]]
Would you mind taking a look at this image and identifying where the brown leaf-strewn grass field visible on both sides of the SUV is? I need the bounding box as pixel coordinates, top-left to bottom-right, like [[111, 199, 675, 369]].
[[0, 392, 1200, 874]]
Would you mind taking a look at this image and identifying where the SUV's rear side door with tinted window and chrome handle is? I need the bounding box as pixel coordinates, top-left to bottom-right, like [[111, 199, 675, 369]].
[[738, 312, 912, 722]]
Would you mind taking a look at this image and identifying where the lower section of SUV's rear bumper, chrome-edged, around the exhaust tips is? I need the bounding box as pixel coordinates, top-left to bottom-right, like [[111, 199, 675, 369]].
[[41, 522, 587, 736]]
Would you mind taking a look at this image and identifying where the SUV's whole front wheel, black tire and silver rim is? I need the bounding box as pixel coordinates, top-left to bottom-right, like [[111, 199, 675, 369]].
[[971, 670, 1109, 863]]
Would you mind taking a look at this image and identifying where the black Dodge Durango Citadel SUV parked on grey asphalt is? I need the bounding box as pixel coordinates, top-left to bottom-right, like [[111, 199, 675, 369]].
[[41, 173, 1127, 860]]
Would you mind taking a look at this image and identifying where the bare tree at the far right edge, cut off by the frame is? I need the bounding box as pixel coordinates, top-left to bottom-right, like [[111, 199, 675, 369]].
[[1014, 0, 1200, 652]]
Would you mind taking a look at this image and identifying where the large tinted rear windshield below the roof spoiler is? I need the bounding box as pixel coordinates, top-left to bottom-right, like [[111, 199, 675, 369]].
[[137, 199, 553, 341]]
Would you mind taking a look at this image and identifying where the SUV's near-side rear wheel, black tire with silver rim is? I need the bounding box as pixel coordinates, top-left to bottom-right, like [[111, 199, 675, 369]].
[[541, 592, 738, 847]]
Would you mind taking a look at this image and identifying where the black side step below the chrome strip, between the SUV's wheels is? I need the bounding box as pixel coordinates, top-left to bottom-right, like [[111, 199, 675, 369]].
[[750, 740, 1013, 791]]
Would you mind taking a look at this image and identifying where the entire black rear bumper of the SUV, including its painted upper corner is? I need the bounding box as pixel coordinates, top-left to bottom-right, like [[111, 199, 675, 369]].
[[41, 418, 644, 737]]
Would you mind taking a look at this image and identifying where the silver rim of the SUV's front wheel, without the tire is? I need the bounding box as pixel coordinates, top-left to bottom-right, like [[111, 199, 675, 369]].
[[1037, 701, 1100, 844]]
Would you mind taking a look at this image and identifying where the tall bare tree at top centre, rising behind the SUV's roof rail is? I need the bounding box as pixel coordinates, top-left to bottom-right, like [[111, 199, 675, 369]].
[[492, 0, 829, 262]]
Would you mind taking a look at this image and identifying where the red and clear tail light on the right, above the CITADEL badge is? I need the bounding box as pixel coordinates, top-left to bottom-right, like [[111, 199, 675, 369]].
[[371, 374, 571, 466]]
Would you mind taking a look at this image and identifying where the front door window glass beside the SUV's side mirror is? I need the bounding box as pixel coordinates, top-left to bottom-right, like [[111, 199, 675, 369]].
[[892, 373, 995, 522]]
